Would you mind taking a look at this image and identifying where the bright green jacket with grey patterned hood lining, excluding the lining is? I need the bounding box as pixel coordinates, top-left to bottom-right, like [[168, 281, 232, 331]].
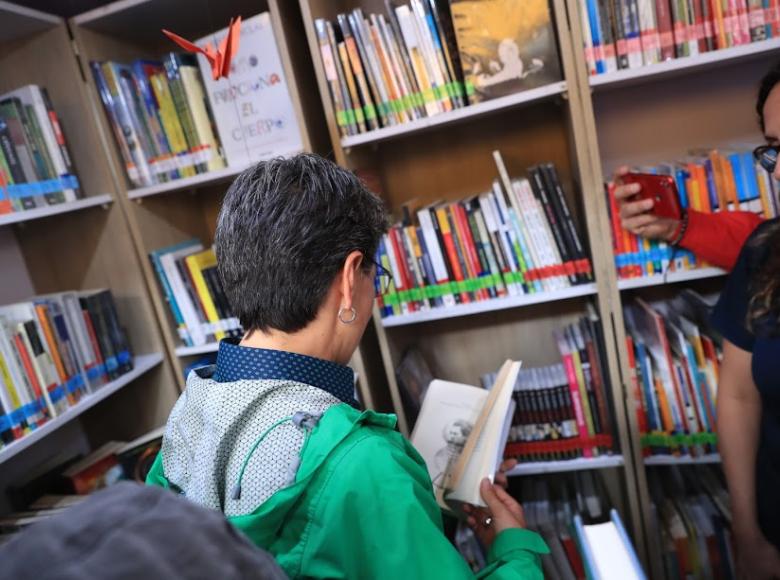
[[147, 404, 548, 580]]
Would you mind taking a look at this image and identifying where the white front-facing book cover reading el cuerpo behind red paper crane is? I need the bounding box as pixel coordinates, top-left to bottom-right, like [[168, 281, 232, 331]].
[[196, 12, 303, 167]]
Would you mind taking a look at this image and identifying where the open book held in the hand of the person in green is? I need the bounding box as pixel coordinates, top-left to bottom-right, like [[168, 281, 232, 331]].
[[412, 360, 520, 511]]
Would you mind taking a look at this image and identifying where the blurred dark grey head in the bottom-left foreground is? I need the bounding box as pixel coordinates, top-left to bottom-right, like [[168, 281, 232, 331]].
[[0, 482, 287, 580]]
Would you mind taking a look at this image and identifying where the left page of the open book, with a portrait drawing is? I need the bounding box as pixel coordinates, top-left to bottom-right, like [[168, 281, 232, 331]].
[[411, 379, 488, 496]]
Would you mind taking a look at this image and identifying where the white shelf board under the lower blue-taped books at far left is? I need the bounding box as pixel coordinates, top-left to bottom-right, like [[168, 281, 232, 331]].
[[0, 353, 163, 464]]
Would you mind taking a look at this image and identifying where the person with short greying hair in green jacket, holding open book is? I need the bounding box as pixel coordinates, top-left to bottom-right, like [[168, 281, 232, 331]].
[[147, 155, 547, 580]]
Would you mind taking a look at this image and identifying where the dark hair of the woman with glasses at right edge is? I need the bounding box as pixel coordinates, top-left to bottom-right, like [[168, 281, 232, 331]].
[[748, 61, 780, 328]]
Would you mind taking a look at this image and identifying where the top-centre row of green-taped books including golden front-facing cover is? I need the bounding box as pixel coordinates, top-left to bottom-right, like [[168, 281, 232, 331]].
[[314, 0, 561, 136]]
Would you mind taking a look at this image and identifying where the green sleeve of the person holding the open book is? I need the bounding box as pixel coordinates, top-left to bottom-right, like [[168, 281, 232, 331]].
[[300, 435, 548, 580]]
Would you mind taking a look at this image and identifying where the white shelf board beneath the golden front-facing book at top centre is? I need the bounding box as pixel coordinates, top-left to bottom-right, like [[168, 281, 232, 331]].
[[341, 81, 566, 149]]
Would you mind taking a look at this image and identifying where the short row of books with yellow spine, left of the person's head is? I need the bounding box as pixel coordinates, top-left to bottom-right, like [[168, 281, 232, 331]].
[[149, 239, 241, 346]]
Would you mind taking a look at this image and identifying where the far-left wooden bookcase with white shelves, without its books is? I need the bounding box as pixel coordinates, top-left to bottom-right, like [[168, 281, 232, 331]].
[[0, 2, 179, 502]]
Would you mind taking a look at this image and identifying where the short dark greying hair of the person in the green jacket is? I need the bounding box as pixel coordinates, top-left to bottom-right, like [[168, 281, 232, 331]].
[[214, 154, 387, 333]]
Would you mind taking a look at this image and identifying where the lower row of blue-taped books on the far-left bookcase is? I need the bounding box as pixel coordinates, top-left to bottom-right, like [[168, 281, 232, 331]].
[[0, 290, 133, 444]]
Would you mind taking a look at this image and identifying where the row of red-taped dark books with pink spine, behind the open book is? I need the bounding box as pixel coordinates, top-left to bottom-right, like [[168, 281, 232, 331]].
[[482, 305, 615, 462]]
